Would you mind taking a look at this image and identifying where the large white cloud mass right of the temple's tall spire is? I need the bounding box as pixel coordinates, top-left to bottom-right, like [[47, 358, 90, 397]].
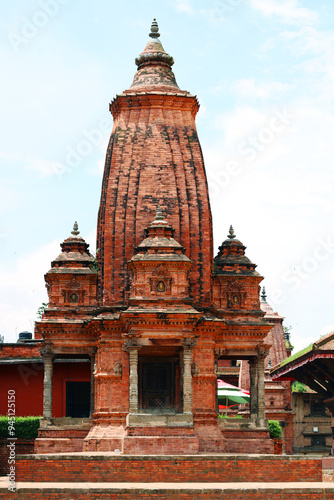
[[205, 83, 334, 360]]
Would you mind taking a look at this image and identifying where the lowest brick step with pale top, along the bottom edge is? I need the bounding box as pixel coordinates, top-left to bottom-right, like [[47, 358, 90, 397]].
[[0, 481, 334, 500]]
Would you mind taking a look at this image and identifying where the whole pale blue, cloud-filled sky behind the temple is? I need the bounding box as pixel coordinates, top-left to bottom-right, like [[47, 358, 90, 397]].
[[0, 0, 334, 349]]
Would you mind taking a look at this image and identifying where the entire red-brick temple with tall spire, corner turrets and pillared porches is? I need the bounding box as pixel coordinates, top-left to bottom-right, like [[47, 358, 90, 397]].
[[36, 20, 272, 454]]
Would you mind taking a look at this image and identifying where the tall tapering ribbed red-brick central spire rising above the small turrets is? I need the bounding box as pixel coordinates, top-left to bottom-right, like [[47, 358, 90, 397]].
[[97, 21, 213, 306]]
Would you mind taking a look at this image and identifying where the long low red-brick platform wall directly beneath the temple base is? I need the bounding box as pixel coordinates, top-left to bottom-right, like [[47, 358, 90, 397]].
[[16, 455, 322, 482]]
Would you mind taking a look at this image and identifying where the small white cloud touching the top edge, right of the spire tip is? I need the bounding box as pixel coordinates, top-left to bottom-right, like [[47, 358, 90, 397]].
[[249, 0, 318, 24]]
